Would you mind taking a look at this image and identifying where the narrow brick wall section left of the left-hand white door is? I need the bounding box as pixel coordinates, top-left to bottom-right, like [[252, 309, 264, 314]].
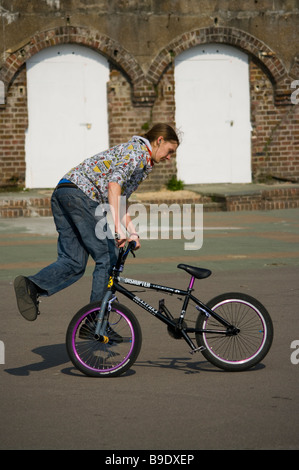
[[0, 67, 28, 187]]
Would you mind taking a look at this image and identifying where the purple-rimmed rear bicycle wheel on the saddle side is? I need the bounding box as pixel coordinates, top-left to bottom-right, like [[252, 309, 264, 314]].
[[196, 293, 274, 372]]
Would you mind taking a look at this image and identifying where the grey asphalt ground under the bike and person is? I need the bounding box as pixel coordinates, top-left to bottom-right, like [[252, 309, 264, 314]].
[[0, 209, 299, 452]]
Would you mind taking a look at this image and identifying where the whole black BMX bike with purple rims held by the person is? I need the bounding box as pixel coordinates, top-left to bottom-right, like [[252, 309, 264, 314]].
[[66, 242, 274, 377]]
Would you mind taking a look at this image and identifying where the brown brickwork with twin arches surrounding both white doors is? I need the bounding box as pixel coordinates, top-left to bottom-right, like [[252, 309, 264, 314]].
[[0, 23, 299, 190]]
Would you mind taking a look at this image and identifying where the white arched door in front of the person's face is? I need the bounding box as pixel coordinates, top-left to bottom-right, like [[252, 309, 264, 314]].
[[175, 44, 251, 184]]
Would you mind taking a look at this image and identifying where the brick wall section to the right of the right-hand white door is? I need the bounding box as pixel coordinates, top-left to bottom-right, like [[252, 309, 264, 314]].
[[250, 61, 299, 181]]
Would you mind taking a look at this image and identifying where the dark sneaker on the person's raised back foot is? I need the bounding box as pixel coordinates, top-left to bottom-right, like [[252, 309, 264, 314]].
[[14, 276, 39, 321]]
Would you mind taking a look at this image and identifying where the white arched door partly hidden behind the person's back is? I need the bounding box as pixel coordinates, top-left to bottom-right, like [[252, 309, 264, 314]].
[[25, 45, 109, 188]]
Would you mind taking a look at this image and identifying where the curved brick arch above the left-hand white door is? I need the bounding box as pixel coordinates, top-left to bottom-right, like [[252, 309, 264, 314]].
[[0, 26, 144, 97]]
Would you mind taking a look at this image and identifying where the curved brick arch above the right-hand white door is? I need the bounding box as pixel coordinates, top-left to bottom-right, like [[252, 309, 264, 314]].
[[147, 27, 290, 104]]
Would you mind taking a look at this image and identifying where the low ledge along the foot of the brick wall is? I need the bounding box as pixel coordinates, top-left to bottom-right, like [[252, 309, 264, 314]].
[[0, 183, 299, 218]]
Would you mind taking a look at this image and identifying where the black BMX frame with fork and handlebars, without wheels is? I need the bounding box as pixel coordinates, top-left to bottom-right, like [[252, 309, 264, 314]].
[[95, 244, 236, 354]]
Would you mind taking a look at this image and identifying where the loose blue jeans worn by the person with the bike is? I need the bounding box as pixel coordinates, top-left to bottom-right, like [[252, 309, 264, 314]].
[[28, 188, 117, 302]]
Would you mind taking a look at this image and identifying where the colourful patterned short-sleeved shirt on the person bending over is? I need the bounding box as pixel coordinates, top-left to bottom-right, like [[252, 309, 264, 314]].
[[63, 136, 152, 203]]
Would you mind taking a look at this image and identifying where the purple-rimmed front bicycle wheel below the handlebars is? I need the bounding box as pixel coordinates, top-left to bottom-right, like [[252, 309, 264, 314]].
[[66, 302, 142, 377]]
